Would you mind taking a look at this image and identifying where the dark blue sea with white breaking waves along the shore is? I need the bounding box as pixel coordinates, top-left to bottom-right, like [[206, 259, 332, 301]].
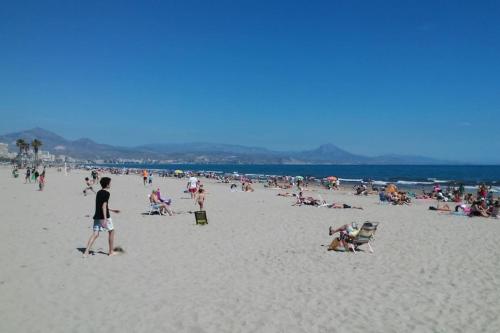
[[93, 163, 500, 185]]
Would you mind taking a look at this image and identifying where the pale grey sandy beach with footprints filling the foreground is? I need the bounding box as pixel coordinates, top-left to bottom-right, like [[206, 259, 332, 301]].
[[0, 167, 500, 332]]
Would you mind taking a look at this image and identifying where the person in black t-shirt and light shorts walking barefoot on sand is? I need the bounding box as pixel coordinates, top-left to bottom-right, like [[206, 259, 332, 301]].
[[83, 177, 120, 258]]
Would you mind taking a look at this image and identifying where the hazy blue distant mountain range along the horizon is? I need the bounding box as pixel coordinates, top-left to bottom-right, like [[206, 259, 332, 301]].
[[0, 127, 450, 164]]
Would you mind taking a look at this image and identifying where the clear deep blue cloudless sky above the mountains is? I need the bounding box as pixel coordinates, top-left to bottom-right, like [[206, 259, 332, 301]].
[[0, 0, 500, 163]]
